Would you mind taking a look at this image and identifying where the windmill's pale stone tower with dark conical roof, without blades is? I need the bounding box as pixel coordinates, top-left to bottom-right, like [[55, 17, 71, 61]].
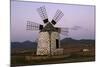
[[37, 23, 63, 55]]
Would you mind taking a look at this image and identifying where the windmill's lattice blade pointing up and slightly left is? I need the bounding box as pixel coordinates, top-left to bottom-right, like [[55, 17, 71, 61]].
[[37, 6, 48, 23]]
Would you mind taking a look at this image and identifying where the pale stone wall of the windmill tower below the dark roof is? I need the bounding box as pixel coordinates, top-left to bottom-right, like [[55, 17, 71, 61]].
[[37, 32, 63, 55]]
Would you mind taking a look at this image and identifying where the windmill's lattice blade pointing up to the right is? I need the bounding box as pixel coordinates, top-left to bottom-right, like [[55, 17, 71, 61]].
[[51, 10, 64, 25]]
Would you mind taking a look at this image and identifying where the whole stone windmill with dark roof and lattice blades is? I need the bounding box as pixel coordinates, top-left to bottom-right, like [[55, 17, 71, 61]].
[[27, 6, 68, 56]]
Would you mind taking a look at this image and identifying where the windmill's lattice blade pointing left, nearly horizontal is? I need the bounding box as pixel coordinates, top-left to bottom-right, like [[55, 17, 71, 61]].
[[26, 21, 43, 31]]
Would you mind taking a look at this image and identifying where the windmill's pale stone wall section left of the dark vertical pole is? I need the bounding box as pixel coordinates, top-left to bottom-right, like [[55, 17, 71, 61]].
[[37, 32, 50, 55]]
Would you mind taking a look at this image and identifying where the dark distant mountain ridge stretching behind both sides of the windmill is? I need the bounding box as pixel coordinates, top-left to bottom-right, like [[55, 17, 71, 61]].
[[11, 38, 95, 49]]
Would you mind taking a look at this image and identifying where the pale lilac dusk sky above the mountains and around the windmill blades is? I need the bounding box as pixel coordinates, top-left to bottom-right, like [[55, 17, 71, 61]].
[[11, 1, 95, 42]]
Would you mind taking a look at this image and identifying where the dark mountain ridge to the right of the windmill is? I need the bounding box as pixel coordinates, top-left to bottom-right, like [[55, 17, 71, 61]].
[[61, 38, 95, 47]]
